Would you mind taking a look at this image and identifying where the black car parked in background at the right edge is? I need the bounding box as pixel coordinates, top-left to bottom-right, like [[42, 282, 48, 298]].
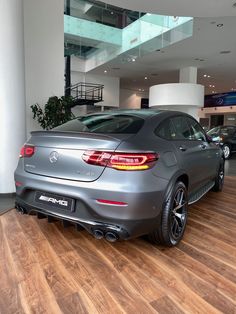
[[207, 125, 236, 159]]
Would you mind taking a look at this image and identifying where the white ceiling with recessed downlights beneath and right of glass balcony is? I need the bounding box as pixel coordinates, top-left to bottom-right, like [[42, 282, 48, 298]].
[[88, 16, 236, 94]]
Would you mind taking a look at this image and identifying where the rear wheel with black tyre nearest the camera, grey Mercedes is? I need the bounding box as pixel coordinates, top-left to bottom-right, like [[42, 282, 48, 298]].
[[149, 181, 188, 247]]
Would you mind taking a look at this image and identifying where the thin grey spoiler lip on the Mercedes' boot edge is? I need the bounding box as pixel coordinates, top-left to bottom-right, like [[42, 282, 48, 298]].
[[30, 131, 124, 142]]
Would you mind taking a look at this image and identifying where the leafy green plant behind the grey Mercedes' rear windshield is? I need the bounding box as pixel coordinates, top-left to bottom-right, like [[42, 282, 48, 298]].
[[30, 96, 74, 130]]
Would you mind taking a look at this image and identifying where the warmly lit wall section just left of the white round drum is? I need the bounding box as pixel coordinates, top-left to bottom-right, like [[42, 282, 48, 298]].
[[120, 89, 148, 109]]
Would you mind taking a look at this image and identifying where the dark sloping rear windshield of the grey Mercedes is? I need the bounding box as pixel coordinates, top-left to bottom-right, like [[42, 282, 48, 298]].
[[53, 114, 144, 134]]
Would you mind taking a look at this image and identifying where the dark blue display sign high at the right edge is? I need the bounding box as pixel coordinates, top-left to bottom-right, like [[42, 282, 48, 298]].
[[204, 92, 236, 107]]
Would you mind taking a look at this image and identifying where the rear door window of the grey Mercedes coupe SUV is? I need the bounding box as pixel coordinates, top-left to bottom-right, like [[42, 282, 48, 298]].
[[171, 116, 194, 140]]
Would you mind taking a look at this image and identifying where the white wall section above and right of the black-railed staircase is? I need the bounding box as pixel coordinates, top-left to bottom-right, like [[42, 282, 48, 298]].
[[71, 71, 120, 107]]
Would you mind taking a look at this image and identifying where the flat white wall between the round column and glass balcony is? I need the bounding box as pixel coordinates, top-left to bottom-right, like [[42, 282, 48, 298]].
[[24, 0, 64, 133]]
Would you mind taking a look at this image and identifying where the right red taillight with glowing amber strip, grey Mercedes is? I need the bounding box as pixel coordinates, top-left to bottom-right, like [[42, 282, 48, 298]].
[[83, 151, 159, 170]]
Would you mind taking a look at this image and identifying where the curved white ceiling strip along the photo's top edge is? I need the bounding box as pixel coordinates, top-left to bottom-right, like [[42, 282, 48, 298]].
[[105, 0, 236, 17]]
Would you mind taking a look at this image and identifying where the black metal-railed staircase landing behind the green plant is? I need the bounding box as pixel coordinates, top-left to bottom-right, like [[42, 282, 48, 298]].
[[66, 82, 104, 107]]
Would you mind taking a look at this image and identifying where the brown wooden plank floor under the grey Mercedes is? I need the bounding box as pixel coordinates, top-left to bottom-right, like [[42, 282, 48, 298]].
[[0, 177, 236, 314]]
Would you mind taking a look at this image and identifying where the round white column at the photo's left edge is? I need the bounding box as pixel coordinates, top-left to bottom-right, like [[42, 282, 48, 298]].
[[0, 0, 25, 193]]
